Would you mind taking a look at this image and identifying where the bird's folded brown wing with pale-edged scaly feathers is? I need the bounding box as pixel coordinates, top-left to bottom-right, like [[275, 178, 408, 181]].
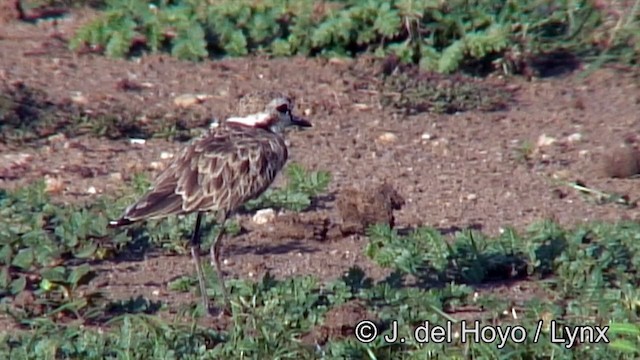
[[112, 127, 287, 223]]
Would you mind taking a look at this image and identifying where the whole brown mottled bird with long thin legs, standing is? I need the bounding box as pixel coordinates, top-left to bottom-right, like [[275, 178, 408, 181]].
[[108, 95, 313, 314]]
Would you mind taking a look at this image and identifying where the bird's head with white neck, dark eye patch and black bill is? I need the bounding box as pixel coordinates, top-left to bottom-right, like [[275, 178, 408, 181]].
[[226, 97, 312, 134]]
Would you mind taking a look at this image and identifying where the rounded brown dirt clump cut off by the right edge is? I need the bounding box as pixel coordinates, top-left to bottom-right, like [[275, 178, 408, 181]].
[[602, 136, 640, 178]]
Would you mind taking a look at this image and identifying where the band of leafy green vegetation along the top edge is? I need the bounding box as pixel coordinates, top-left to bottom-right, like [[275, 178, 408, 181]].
[[71, 0, 640, 73]]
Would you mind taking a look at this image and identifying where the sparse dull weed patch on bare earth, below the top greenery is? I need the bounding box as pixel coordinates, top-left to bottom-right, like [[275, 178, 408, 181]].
[[362, 56, 512, 114]]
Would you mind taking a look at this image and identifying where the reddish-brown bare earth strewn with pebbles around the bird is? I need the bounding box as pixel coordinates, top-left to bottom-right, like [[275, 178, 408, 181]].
[[0, 10, 640, 332]]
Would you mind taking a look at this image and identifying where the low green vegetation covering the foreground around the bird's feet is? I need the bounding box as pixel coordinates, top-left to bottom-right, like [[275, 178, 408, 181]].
[[0, 169, 640, 359]]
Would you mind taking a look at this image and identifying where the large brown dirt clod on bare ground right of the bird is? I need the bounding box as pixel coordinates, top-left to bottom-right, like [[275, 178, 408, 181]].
[[336, 183, 405, 236]]
